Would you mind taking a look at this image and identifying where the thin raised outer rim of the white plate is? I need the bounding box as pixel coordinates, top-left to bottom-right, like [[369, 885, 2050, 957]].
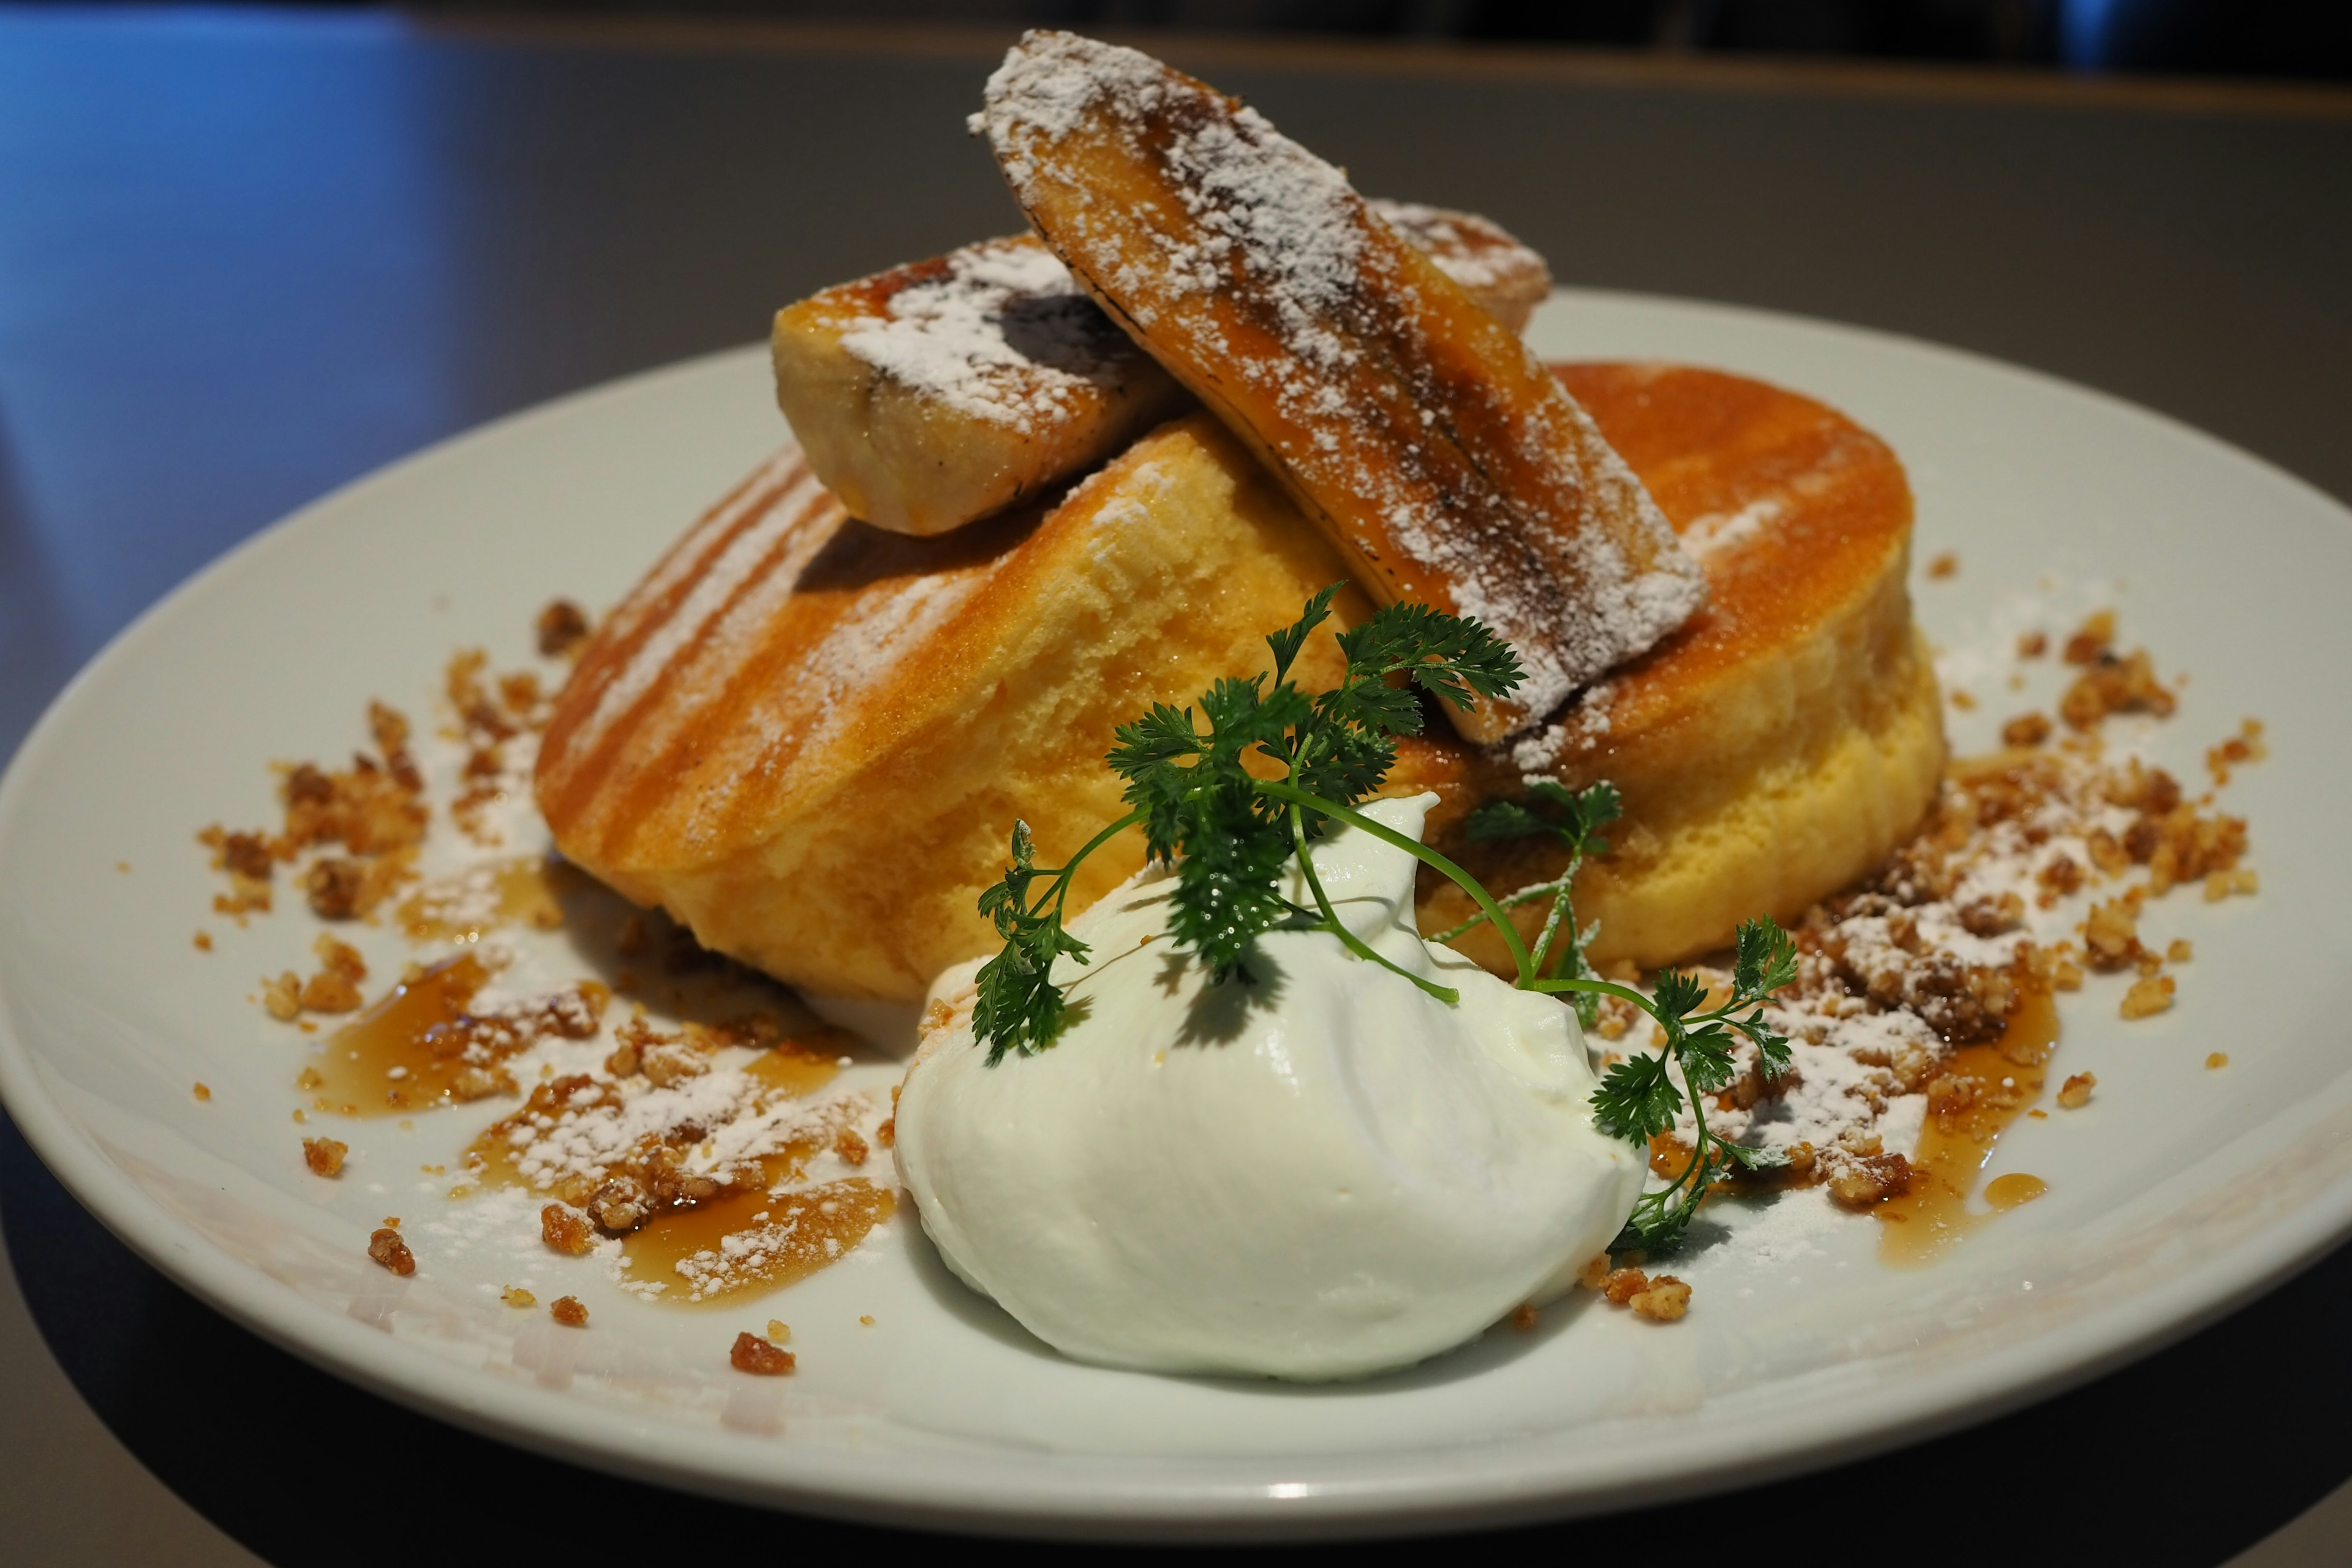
[[0, 289, 2352, 1542]]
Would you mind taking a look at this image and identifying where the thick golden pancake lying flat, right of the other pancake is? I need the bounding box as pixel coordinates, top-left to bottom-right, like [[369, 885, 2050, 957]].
[[1397, 364, 1943, 968]]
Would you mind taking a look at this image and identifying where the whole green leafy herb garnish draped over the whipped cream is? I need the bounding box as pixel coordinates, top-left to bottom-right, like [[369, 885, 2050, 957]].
[[971, 583, 1797, 1251]]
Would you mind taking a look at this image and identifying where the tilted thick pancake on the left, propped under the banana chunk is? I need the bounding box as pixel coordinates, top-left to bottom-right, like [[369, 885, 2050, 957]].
[[537, 414, 1369, 1001]]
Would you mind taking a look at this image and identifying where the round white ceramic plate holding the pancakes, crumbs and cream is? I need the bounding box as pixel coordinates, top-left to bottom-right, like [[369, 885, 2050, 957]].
[[0, 294, 2352, 1540]]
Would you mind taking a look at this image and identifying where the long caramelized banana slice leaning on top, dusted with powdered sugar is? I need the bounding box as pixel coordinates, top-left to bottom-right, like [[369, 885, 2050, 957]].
[[981, 31, 1705, 741]]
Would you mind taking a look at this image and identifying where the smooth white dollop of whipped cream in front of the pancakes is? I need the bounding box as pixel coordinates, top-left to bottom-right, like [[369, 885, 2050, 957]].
[[896, 794, 1642, 1380]]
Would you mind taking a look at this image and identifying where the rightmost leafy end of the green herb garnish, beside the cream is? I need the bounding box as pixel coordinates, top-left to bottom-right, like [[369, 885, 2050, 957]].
[[1536, 914, 1797, 1251]]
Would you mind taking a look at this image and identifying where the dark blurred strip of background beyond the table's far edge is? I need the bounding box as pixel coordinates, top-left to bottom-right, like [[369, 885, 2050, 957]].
[[341, 0, 2352, 80]]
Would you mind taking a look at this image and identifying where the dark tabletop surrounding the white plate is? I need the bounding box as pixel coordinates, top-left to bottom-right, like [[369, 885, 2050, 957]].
[[0, 9, 2352, 1566]]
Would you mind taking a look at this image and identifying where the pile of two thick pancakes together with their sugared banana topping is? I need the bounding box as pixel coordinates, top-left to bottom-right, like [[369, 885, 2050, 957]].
[[538, 36, 1943, 1001]]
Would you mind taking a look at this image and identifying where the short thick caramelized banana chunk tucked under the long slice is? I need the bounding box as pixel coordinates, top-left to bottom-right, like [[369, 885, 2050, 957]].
[[772, 235, 1190, 533]]
